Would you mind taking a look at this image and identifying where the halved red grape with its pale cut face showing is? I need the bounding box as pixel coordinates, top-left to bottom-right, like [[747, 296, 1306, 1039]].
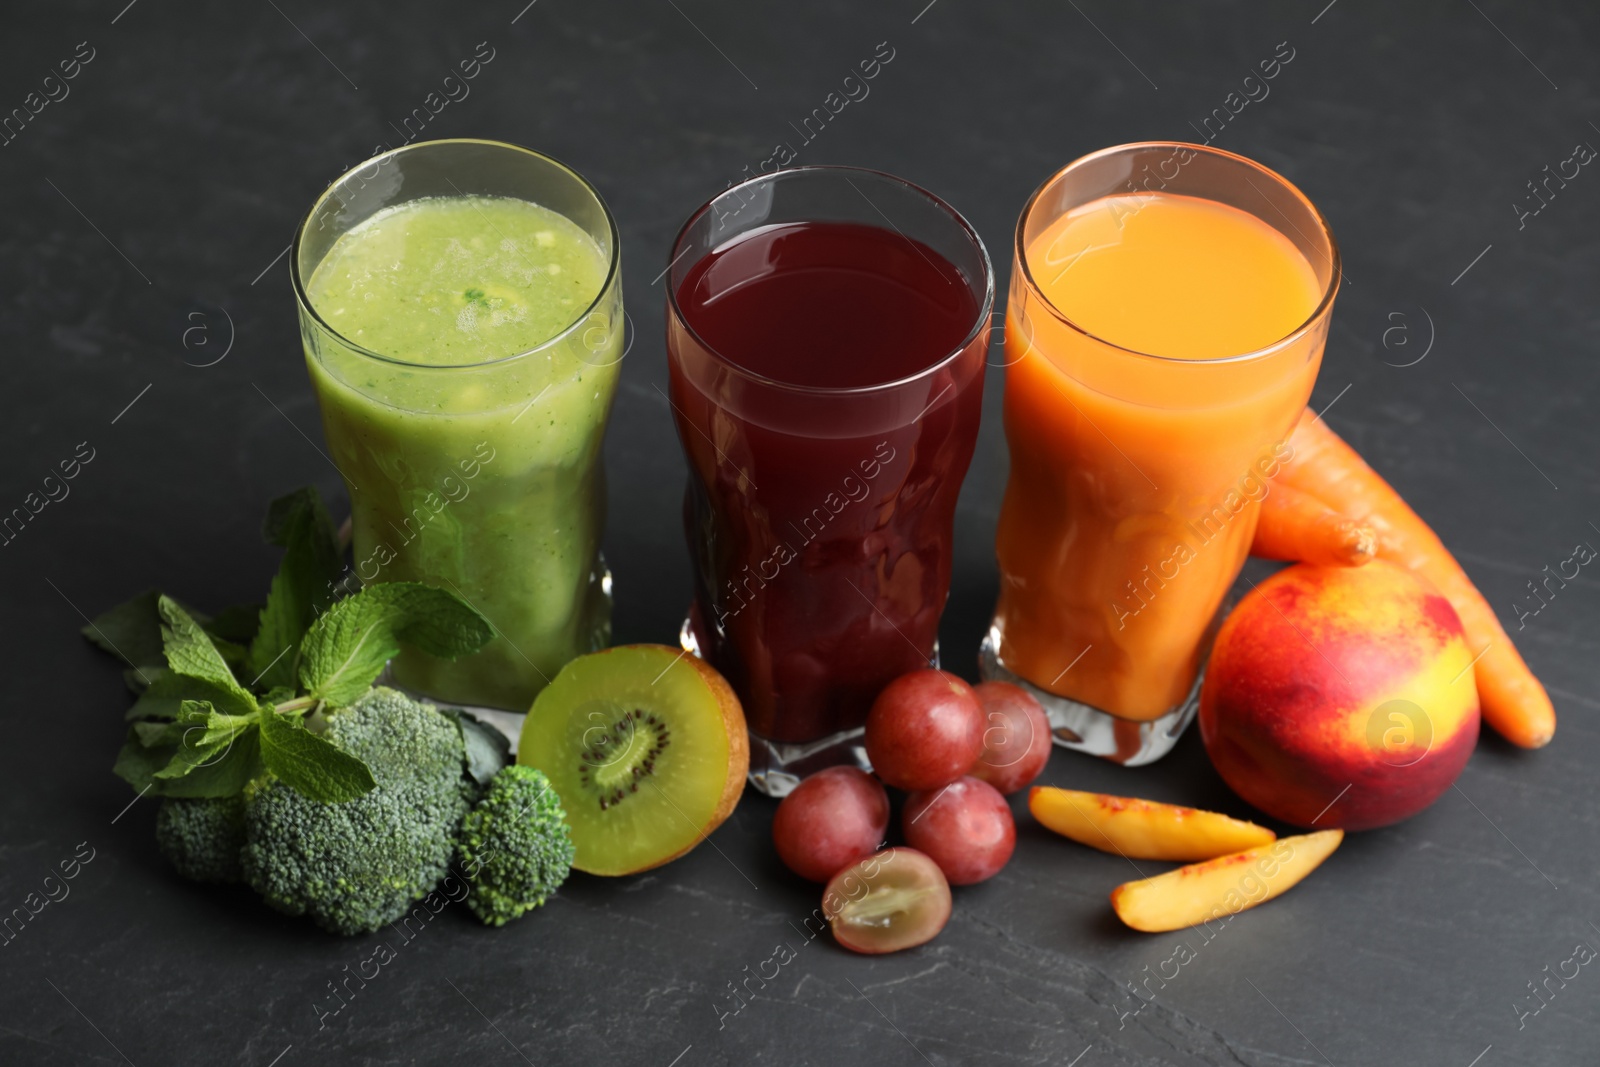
[[822, 848, 950, 955]]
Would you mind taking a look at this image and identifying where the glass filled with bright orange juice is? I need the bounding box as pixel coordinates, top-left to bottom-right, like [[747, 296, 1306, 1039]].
[[981, 144, 1339, 765]]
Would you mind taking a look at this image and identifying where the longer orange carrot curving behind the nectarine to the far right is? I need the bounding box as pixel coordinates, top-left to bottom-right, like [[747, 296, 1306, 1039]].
[[1267, 410, 1555, 749]]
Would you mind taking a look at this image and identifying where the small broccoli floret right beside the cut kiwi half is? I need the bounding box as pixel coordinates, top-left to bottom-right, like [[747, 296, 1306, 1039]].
[[456, 766, 573, 926]]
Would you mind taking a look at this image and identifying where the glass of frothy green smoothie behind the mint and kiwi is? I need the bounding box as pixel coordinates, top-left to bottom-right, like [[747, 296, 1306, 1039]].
[[293, 141, 624, 710]]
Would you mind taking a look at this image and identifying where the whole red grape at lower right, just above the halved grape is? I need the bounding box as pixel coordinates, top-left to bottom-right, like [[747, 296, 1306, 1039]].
[[901, 777, 1016, 886]]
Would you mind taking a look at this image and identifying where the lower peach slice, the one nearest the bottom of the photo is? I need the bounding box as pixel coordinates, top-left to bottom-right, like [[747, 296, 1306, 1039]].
[[1110, 830, 1344, 934]]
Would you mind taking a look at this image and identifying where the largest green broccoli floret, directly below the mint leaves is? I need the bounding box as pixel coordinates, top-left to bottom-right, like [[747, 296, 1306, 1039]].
[[243, 688, 477, 934]]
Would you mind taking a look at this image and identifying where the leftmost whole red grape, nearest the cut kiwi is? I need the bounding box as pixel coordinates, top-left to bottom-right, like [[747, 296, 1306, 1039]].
[[773, 766, 890, 881]]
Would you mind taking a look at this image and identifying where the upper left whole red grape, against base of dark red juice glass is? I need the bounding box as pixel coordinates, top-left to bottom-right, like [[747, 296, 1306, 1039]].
[[866, 670, 984, 790]]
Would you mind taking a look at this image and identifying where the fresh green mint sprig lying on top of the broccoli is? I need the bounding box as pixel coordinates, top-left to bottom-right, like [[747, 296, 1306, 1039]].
[[83, 490, 493, 801]]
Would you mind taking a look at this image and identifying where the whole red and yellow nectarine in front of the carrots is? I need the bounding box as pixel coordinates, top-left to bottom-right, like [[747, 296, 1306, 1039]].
[[1200, 560, 1478, 830]]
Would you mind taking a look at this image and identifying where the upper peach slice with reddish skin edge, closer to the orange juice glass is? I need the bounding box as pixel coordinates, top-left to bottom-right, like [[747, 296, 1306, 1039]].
[[1027, 785, 1277, 862]]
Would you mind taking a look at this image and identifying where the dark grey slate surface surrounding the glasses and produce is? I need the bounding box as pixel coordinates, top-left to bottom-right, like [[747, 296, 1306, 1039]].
[[0, 0, 1600, 1067]]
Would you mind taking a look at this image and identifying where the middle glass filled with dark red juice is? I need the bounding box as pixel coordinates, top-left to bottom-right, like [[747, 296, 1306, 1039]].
[[667, 166, 994, 795]]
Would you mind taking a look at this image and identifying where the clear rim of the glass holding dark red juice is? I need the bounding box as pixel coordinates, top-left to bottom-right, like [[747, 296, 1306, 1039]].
[[667, 163, 995, 397]]
